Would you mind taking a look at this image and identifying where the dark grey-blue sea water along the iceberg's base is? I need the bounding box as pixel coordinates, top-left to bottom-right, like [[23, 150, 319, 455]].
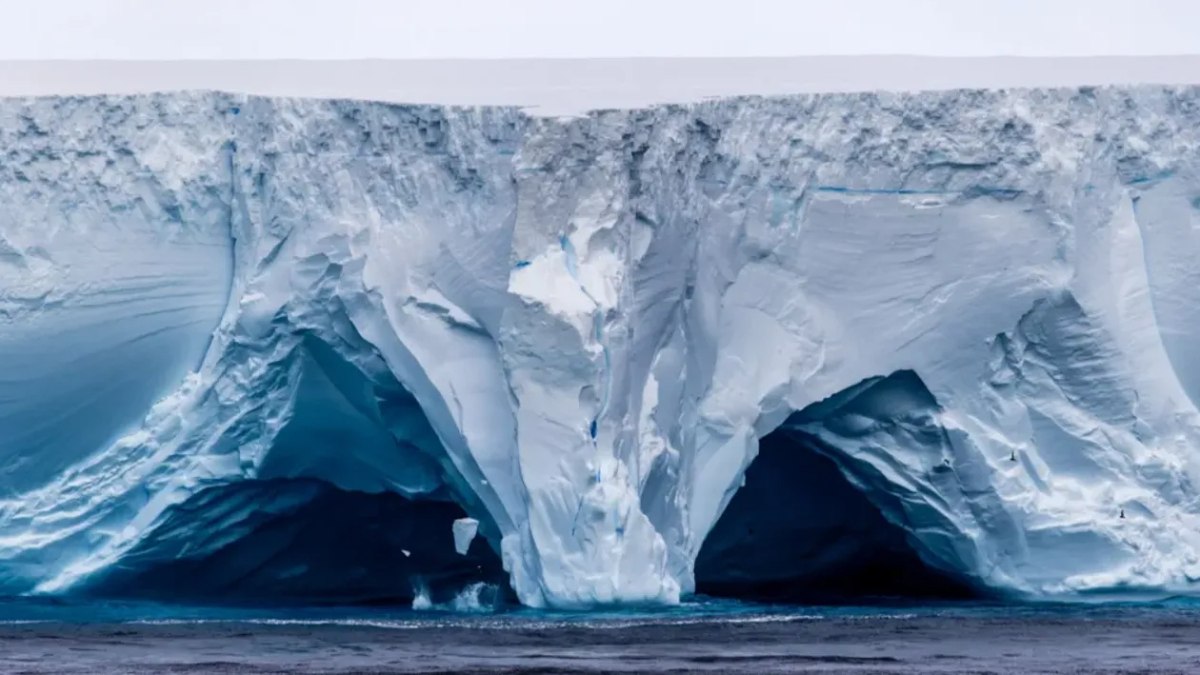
[[0, 593, 1200, 674]]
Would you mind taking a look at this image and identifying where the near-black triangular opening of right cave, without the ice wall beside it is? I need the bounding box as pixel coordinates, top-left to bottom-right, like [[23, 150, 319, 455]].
[[695, 428, 978, 604]]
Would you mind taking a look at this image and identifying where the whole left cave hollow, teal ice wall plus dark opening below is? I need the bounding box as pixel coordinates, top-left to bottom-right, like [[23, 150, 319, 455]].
[[82, 336, 512, 607]]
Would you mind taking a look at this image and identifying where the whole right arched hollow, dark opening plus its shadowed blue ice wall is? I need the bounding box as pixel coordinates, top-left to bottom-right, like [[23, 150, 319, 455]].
[[695, 371, 978, 599]]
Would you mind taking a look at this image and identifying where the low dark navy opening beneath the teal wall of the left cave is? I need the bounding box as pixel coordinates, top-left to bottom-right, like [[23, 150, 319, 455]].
[[85, 479, 511, 607]]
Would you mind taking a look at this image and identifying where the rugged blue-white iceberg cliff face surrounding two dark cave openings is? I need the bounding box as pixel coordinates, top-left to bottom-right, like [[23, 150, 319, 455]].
[[0, 88, 1200, 608]]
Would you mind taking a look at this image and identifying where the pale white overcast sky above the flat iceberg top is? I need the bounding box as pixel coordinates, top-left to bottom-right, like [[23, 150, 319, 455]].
[[0, 0, 1200, 59]]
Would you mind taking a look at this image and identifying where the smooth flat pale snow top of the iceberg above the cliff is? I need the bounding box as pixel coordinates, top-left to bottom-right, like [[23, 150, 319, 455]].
[[7, 56, 1200, 115]]
